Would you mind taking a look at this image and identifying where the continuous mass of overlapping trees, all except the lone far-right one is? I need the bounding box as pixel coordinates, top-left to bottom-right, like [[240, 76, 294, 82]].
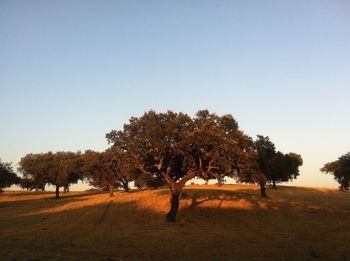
[[0, 110, 303, 222]]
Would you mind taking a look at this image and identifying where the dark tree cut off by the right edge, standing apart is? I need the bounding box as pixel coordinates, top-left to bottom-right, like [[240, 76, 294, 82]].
[[321, 152, 350, 191]]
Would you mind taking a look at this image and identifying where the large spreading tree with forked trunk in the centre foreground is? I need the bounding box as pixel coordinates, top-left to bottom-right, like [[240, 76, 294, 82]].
[[106, 110, 254, 222]]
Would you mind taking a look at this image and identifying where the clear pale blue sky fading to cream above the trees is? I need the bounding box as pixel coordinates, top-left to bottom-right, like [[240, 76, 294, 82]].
[[0, 0, 350, 189]]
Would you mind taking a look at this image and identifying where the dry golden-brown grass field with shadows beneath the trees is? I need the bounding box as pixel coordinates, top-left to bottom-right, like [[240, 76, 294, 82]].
[[0, 185, 350, 260]]
